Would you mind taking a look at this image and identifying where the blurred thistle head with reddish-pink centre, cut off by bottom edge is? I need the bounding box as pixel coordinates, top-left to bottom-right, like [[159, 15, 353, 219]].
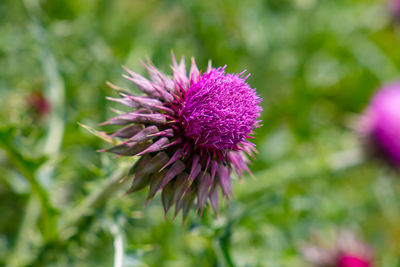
[[302, 230, 374, 267]]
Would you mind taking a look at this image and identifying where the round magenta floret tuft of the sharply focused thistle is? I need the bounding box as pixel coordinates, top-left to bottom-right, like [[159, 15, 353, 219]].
[[180, 68, 261, 151]]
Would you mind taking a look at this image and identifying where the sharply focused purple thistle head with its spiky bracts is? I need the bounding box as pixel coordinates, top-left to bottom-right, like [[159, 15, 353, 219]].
[[99, 55, 262, 220]]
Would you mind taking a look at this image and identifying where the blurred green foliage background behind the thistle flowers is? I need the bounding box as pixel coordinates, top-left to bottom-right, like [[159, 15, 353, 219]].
[[0, 0, 400, 267]]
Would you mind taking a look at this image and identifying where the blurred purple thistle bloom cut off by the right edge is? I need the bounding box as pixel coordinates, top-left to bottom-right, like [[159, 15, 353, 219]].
[[360, 83, 400, 166]]
